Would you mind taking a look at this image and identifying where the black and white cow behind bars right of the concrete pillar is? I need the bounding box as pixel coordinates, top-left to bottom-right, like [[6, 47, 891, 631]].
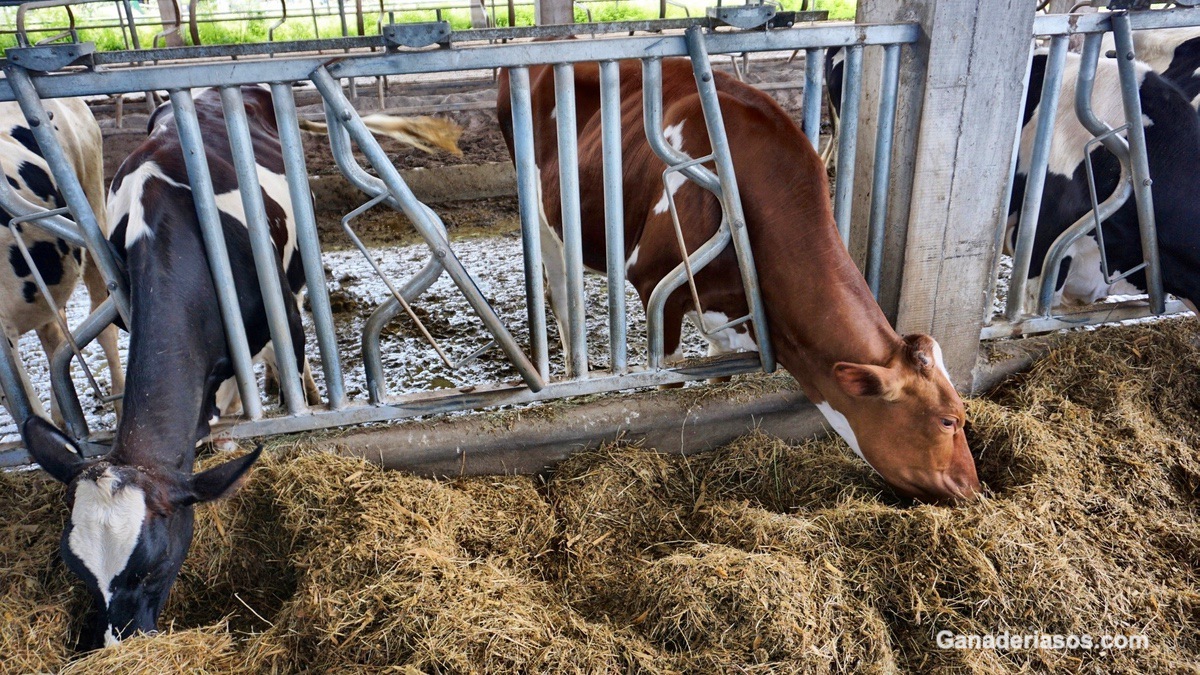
[[1007, 49, 1200, 309]]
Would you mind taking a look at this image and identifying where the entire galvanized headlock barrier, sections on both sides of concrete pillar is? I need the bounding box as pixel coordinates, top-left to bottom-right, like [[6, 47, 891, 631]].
[[0, 6, 1200, 464]]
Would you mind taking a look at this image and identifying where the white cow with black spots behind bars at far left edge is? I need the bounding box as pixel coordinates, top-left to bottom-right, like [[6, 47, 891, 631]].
[[0, 98, 125, 420]]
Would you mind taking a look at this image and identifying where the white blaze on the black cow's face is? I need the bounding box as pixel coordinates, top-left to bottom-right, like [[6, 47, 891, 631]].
[[67, 468, 146, 605]]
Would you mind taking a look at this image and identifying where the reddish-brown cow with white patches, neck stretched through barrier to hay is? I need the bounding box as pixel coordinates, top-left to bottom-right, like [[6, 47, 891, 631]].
[[498, 60, 979, 502]]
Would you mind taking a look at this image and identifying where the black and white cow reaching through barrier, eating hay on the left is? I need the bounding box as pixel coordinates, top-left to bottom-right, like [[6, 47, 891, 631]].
[[24, 88, 304, 649]]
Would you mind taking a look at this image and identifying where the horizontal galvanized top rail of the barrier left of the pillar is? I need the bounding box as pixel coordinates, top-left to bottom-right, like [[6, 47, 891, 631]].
[[0, 24, 920, 101]]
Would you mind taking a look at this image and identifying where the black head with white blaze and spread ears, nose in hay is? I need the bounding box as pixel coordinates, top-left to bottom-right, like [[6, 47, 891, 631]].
[[23, 417, 262, 650]]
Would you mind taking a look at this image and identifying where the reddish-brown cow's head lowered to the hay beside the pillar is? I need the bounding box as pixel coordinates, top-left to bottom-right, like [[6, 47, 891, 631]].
[[818, 335, 979, 503]]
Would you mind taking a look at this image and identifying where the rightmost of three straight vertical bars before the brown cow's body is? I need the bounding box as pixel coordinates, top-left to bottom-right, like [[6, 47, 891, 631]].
[[600, 61, 629, 372]]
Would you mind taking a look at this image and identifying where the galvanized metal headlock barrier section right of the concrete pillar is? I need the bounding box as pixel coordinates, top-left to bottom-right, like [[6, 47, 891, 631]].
[[982, 8, 1200, 339]]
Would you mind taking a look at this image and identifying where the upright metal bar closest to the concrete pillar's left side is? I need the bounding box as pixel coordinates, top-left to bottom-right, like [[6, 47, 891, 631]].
[[866, 44, 900, 294]]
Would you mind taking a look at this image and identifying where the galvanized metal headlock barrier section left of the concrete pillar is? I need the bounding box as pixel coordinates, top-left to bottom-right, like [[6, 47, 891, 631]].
[[0, 13, 919, 464]]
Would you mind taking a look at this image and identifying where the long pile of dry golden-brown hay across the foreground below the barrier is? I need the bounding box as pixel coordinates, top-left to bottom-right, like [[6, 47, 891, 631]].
[[0, 321, 1200, 674]]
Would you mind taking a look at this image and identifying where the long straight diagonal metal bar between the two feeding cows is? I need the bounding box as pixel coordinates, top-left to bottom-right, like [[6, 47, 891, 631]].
[[311, 67, 545, 390]]
